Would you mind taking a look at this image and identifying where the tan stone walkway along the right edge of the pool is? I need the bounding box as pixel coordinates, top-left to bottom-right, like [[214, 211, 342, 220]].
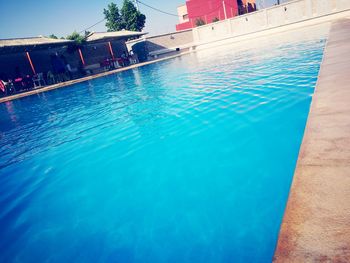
[[274, 19, 350, 262]]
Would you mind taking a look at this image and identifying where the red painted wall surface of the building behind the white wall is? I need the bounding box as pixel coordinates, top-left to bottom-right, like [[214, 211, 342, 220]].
[[176, 0, 238, 30]]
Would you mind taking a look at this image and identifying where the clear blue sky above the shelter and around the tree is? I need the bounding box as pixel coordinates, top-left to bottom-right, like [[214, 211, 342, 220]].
[[0, 0, 276, 39]]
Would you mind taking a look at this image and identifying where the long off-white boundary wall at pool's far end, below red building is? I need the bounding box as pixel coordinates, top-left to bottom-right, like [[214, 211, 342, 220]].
[[193, 0, 350, 44]]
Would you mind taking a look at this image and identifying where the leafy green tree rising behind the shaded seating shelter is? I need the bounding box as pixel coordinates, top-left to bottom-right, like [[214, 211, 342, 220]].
[[103, 0, 146, 32]]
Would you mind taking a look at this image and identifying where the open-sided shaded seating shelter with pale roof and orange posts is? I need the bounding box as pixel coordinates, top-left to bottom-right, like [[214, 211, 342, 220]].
[[0, 30, 146, 97]]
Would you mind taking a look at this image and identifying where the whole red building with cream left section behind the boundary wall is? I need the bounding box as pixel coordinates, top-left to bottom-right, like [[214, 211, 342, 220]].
[[176, 0, 256, 31]]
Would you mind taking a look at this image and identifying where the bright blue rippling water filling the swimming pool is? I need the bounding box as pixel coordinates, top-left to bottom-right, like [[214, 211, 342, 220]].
[[0, 36, 325, 263]]
